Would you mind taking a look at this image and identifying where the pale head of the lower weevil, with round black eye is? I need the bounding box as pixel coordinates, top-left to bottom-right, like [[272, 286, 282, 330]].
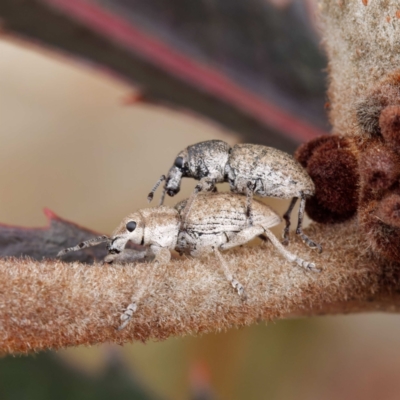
[[108, 212, 144, 253]]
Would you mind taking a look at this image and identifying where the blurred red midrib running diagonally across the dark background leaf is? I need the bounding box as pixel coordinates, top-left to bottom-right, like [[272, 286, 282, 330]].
[[42, 0, 326, 142]]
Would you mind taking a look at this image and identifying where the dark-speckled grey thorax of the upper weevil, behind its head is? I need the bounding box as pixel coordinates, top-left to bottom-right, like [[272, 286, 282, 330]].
[[187, 140, 231, 182]]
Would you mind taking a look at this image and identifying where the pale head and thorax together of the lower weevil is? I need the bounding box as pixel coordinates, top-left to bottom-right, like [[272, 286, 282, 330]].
[[109, 206, 180, 251]]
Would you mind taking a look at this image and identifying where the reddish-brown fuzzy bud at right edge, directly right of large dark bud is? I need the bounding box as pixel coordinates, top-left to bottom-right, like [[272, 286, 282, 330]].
[[359, 142, 400, 190]]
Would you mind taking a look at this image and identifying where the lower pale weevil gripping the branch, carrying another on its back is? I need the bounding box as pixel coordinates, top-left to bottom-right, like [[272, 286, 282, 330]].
[[59, 193, 318, 329]]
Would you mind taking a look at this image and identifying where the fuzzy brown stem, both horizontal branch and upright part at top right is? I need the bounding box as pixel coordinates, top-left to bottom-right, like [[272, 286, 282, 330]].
[[0, 0, 400, 353]]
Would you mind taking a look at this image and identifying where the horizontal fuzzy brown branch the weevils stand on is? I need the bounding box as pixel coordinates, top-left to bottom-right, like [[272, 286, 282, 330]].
[[0, 222, 400, 353]]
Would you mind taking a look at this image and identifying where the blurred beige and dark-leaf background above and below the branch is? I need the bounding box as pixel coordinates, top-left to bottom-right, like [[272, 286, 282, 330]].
[[0, 0, 400, 400]]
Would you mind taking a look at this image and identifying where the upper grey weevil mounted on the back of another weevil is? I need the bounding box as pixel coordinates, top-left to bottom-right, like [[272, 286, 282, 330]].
[[147, 140, 322, 252]]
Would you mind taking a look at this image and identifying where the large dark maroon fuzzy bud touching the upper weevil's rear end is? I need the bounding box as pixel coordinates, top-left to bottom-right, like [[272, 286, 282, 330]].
[[295, 135, 359, 223]]
